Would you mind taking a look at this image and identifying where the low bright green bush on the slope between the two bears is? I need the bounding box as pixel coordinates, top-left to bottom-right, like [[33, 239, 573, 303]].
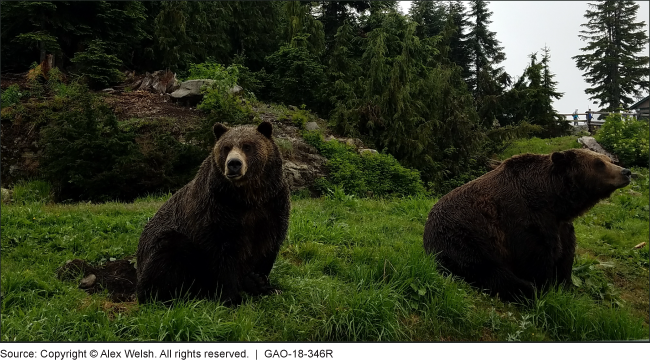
[[303, 132, 425, 197]]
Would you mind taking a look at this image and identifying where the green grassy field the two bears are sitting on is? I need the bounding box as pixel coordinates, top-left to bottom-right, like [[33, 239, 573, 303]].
[[0, 140, 649, 341]]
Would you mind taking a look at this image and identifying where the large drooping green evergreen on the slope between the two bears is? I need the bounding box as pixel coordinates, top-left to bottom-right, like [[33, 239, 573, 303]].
[[330, 10, 482, 185]]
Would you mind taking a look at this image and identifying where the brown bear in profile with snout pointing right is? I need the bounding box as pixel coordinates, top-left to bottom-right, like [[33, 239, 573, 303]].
[[424, 149, 631, 301]]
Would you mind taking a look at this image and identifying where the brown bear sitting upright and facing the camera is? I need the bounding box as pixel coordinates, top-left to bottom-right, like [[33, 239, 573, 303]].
[[136, 122, 290, 304]]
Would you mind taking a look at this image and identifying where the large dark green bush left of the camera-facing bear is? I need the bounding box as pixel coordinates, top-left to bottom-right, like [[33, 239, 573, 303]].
[[41, 86, 141, 201]]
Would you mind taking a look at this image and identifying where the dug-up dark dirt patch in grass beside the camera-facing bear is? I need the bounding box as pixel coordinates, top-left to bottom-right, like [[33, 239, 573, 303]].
[[56, 257, 137, 303]]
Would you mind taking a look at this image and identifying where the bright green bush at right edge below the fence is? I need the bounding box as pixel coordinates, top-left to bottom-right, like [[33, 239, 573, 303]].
[[596, 113, 650, 168]]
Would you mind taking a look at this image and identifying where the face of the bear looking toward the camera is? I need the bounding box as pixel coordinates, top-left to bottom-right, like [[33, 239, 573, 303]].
[[212, 121, 277, 186]]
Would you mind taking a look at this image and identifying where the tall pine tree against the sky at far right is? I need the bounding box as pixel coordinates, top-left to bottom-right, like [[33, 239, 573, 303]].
[[573, 1, 650, 111]]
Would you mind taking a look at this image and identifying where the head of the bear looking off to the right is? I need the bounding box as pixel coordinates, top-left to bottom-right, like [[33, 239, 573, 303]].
[[551, 149, 632, 199]]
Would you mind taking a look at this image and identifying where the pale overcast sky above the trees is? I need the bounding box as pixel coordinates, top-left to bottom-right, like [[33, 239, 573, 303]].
[[400, 1, 650, 118]]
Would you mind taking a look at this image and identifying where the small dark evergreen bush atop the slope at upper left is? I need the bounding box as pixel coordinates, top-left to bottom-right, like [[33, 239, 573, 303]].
[[70, 40, 124, 88]]
